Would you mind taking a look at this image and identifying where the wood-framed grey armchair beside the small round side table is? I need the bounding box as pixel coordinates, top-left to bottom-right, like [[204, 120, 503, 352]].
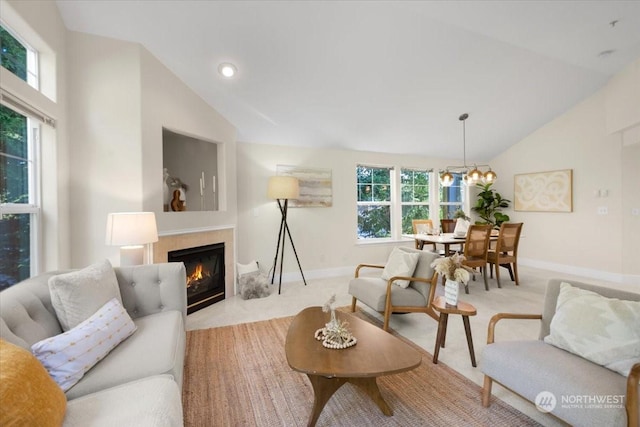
[[348, 247, 439, 331]]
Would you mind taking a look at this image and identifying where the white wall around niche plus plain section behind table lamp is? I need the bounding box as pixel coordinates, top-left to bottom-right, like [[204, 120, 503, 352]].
[[68, 32, 236, 267]]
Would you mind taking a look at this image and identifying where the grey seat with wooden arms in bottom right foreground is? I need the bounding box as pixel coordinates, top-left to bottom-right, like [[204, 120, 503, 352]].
[[481, 279, 640, 427]]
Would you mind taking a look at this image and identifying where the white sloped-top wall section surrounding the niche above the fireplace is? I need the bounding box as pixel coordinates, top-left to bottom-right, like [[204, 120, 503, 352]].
[[141, 49, 237, 233]]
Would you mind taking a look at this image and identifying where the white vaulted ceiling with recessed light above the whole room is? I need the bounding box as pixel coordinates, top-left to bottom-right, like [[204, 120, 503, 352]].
[[57, 0, 640, 161]]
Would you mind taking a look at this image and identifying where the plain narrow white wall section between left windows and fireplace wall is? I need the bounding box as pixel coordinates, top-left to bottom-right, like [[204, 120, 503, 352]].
[[67, 32, 143, 267]]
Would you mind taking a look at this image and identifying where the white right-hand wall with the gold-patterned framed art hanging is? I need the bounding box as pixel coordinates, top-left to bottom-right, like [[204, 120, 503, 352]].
[[491, 56, 640, 282]]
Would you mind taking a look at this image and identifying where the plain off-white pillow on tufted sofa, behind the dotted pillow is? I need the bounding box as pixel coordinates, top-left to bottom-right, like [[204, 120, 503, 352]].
[[49, 260, 122, 331]]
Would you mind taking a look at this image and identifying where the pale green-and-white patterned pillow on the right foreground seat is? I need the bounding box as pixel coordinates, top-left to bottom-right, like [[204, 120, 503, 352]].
[[544, 283, 640, 377]]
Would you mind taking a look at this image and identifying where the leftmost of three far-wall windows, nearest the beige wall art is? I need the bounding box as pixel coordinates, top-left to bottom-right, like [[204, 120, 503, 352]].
[[356, 165, 393, 239]]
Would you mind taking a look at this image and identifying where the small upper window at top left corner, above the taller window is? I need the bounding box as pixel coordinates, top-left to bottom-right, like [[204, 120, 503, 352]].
[[0, 25, 38, 89]]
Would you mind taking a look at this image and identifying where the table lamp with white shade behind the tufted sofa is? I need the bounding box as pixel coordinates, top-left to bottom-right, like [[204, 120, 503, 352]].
[[105, 212, 158, 265]]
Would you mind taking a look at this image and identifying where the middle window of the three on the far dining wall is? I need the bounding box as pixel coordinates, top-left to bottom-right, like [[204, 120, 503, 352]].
[[400, 169, 431, 234]]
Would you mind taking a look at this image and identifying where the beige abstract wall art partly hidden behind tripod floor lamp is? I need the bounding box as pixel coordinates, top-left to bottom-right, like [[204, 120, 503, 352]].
[[276, 165, 333, 208]]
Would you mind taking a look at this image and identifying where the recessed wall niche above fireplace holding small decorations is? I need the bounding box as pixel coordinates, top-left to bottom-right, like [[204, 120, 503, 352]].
[[162, 128, 219, 212]]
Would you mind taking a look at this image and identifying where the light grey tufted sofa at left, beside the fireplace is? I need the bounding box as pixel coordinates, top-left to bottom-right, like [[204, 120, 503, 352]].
[[0, 263, 187, 426]]
